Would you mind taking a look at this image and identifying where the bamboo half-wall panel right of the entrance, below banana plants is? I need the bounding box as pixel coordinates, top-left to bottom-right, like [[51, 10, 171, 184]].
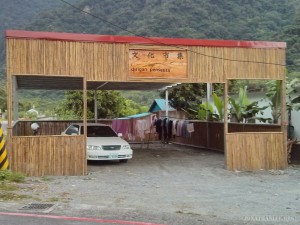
[[226, 133, 287, 171]]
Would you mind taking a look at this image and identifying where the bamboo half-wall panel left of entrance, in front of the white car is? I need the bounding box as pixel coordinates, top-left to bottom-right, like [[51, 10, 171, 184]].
[[9, 135, 87, 176]]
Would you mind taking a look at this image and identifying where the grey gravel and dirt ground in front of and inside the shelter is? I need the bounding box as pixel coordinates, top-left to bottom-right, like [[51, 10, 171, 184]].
[[0, 144, 300, 225]]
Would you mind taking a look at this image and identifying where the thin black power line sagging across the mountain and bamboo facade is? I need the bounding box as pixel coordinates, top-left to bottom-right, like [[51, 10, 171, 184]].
[[59, 0, 286, 67]]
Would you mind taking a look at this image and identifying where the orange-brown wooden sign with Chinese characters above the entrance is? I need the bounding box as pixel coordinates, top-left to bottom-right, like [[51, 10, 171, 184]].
[[129, 49, 188, 79]]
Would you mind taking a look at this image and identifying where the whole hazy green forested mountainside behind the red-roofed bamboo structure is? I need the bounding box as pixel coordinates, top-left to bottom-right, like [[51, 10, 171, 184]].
[[0, 0, 300, 112]]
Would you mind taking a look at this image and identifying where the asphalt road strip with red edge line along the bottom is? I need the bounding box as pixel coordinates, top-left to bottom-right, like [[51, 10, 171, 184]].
[[0, 209, 237, 225]]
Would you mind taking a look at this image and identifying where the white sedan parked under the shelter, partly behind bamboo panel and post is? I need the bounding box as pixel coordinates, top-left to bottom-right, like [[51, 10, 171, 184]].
[[62, 123, 133, 162]]
